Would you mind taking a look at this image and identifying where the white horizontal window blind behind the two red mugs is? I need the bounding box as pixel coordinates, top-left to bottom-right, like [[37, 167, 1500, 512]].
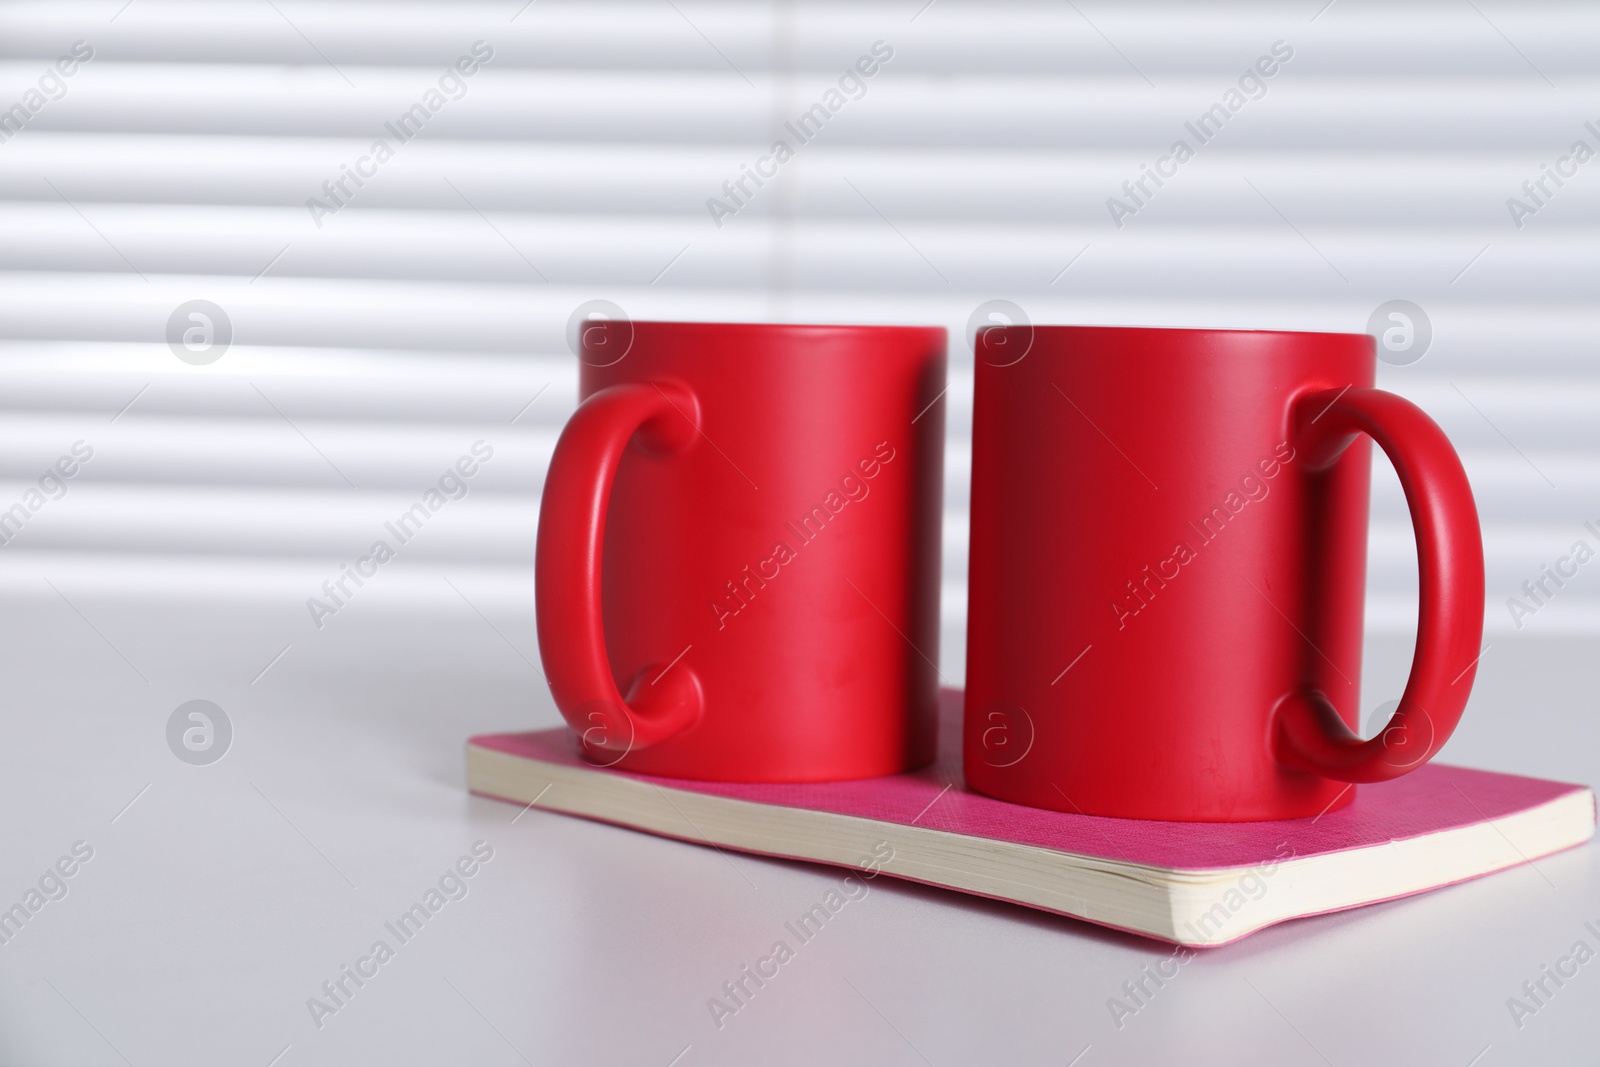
[[0, 0, 1600, 677]]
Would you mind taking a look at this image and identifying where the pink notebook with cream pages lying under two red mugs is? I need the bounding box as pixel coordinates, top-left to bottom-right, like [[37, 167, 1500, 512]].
[[467, 689, 1595, 945]]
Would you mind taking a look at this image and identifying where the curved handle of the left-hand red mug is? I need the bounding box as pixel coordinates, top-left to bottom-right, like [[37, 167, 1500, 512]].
[[534, 382, 704, 758]]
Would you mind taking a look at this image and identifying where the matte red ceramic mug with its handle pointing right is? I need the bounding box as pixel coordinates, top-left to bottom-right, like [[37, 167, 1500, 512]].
[[963, 326, 1483, 821]]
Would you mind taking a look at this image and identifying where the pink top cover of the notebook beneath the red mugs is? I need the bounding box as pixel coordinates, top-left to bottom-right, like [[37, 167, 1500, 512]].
[[470, 689, 1587, 936]]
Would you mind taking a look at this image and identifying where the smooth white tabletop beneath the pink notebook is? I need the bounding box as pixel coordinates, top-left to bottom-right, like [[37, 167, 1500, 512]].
[[0, 582, 1600, 1067]]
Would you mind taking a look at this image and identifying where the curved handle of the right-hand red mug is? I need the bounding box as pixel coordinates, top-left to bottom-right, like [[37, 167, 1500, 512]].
[[1272, 387, 1483, 782]]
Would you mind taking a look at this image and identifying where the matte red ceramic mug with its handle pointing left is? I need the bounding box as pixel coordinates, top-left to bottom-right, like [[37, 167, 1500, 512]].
[[536, 322, 946, 782]]
